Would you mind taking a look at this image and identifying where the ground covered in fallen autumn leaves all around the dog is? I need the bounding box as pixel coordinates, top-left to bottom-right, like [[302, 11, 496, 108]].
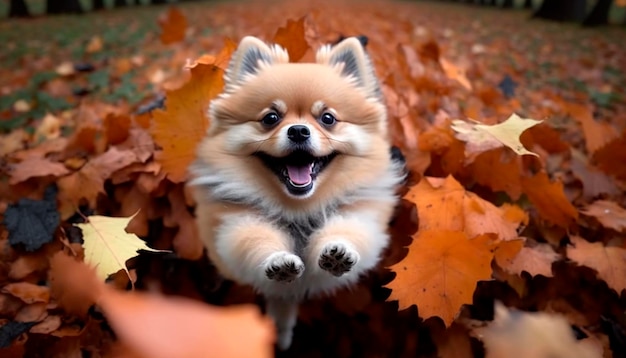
[[0, 1, 626, 357]]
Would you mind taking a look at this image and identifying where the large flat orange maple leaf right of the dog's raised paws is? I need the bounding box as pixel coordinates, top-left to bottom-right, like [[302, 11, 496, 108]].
[[387, 230, 493, 326]]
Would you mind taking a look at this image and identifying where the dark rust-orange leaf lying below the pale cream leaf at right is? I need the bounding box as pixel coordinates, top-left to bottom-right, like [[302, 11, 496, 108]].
[[522, 171, 578, 228]]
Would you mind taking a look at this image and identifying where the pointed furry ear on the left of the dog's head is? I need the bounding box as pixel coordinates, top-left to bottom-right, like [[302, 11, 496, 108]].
[[225, 36, 289, 90]]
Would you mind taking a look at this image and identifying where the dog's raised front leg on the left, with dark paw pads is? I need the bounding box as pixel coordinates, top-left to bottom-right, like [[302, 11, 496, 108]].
[[214, 214, 304, 287]]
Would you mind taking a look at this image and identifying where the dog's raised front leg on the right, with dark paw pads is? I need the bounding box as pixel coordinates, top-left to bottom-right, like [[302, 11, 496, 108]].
[[306, 210, 389, 277]]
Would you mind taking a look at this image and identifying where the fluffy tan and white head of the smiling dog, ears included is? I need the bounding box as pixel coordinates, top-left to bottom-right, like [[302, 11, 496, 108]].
[[197, 37, 389, 208]]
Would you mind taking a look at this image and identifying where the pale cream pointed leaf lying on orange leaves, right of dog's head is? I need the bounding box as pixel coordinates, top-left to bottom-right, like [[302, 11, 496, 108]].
[[452, 113, 543, 162]]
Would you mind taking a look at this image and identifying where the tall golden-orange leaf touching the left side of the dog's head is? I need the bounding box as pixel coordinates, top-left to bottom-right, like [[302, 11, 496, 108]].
[[151, 63, 224, 183]]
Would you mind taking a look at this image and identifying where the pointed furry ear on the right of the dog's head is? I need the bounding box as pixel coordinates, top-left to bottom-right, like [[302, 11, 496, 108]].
[[316, 37, 382, 99]]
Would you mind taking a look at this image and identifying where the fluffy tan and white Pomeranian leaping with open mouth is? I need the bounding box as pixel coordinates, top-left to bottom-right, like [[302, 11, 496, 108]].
[[190, 37, 404, 349]]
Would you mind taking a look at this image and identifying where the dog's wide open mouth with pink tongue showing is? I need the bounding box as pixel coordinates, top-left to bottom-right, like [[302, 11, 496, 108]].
[[256, 150, 337, 195]]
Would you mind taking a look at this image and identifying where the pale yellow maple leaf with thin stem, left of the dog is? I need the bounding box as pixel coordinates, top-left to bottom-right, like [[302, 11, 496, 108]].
[[74, 215, 167, 281]]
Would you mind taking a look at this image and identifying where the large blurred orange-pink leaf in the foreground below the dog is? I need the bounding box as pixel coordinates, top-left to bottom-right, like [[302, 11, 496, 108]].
[[51, 253, 274, 358]]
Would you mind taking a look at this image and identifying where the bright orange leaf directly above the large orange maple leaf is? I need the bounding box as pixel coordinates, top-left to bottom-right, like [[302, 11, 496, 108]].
[[404, 176, 528, 240]]
